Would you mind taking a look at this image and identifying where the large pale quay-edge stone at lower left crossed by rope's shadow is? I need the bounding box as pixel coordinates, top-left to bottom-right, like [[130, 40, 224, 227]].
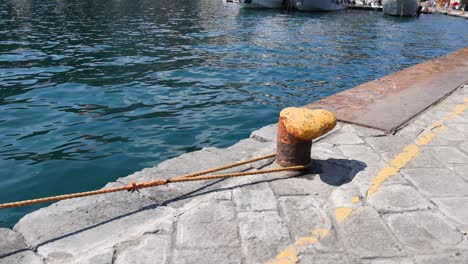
[[15, 188, 174, 258]]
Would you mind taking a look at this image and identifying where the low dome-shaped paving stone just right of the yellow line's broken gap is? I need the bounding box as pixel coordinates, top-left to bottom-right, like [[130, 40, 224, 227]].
[[367, 185, 434, 213]]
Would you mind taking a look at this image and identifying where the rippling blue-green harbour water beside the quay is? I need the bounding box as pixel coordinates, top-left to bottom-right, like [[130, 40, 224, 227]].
[[0, 0, 468, 226]]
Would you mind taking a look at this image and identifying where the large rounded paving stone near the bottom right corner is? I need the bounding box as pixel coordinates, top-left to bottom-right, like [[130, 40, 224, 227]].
[[387, 212, 463, 254]]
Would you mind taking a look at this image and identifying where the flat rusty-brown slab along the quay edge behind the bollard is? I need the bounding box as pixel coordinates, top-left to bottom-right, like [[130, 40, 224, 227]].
[[305, 47, 468, 133]]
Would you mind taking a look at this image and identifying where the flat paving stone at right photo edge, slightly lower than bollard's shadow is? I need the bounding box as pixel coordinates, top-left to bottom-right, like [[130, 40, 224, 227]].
[[401, 168, 468, 196]]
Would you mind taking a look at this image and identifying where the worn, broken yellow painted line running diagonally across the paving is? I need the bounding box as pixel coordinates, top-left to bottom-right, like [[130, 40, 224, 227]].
[[268, 98, 468, 264]]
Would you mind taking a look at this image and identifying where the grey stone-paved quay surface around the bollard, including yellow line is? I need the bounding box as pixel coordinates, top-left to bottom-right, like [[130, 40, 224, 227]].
[[0, 82, 468, 264]]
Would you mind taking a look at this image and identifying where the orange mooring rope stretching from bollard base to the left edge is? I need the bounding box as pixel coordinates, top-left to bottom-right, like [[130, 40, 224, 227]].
[[0, 153, 310, 209]]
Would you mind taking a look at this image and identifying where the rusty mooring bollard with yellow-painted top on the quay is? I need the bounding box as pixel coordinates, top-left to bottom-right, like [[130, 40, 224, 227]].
[[276, 107, 336, 167]]
